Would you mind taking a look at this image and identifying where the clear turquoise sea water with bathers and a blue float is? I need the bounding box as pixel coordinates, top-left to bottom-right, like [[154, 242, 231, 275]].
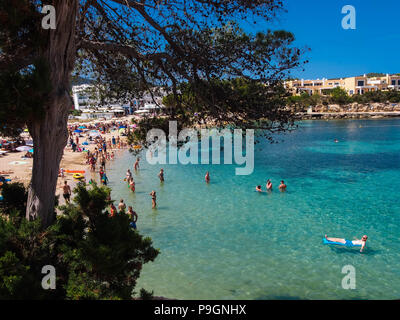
[[107, 120, 400, 299]]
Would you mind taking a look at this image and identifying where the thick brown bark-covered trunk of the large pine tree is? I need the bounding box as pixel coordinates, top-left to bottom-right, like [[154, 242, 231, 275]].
[[26, 0, 79, 227]]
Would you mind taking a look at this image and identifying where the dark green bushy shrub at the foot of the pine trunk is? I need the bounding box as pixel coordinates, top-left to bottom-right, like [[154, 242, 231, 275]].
[[0, 184, 158, 299]]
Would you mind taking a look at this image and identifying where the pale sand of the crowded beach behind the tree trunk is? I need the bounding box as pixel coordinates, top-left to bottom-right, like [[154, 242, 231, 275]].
[[0, 116, 132, 204]]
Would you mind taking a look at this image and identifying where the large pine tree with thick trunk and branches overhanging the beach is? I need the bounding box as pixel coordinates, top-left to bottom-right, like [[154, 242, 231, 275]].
[[0, 0, 303, 227]]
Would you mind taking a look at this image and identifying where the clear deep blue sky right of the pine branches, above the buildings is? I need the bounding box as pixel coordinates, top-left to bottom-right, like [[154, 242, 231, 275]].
[[243, 0, 400, 79]]
